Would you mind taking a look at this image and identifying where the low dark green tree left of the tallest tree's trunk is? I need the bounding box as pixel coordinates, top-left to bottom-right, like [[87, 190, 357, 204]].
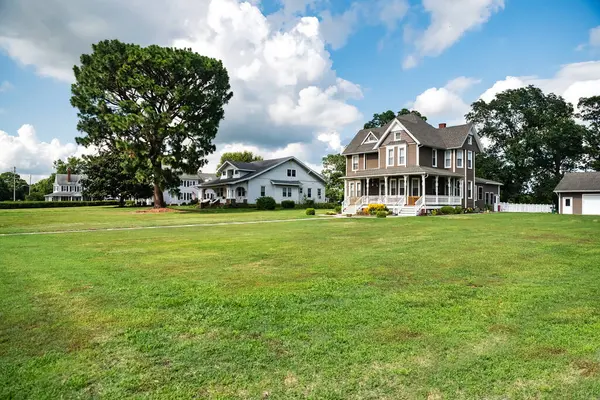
[[81, 152, 153, 206]]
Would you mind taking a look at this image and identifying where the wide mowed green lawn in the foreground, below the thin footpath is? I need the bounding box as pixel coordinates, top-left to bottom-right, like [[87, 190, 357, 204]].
[[0, 210, 600, 399]]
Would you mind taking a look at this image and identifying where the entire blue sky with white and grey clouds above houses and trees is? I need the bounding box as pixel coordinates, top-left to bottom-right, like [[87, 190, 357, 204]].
[[0, 0, 600, 176]]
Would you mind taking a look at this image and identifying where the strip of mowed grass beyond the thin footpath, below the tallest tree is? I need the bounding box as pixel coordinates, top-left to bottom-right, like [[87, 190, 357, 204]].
[[0, 206, 326, 234]]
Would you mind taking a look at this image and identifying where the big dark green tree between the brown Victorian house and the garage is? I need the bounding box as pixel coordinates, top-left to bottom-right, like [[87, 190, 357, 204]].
[[466, 86, 585, 202]]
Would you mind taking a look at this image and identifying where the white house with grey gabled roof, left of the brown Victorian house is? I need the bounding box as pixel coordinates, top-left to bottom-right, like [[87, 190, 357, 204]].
[[198, 157, 326, 204]]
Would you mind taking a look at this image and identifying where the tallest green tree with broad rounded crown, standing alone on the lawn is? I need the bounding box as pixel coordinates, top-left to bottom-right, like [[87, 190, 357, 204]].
[[71, 40, 233, 207]]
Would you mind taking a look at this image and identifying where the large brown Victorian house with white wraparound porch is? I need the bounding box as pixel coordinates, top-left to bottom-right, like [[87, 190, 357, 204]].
[[342, 114, 501, 215]]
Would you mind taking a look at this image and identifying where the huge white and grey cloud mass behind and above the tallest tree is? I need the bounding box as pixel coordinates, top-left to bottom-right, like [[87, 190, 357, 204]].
[[0, 0, 364, 172]]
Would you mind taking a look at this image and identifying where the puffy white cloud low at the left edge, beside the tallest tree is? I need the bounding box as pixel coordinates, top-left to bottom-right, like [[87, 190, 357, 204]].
[[0, 125, 93, 175]]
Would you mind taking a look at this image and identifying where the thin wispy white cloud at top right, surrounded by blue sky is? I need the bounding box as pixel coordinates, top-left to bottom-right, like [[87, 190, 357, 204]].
[[403, 0, 504, 69]]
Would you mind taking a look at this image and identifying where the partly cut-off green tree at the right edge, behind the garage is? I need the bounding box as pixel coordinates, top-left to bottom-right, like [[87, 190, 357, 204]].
[[577, 96, 600, 171]]
